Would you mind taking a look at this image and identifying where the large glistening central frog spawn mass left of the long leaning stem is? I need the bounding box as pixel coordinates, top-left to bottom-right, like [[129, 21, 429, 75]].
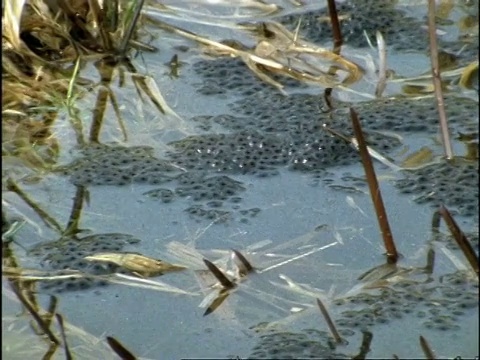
[[184, 92, 400, 177]]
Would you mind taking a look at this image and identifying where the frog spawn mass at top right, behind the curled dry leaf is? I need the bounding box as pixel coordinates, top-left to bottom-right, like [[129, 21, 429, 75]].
[[275, 0, 478, 63]]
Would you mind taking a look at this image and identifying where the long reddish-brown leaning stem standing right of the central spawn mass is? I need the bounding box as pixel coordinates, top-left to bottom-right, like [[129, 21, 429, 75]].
[[350, 108, 398, 263]]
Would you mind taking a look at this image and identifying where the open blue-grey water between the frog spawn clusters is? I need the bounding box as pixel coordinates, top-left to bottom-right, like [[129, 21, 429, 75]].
[[2, 4, 478, 359]]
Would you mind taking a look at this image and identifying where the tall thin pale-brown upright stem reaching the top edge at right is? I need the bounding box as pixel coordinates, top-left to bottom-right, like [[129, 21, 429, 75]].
[[428, 0, 453, 159]]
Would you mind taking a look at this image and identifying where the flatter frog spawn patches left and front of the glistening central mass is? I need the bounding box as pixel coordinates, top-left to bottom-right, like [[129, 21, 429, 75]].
[[59, 145, 251, 221]]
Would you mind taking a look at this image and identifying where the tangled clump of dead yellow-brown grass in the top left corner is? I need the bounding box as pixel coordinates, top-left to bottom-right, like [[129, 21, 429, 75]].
[[2, 0, 156, 168]]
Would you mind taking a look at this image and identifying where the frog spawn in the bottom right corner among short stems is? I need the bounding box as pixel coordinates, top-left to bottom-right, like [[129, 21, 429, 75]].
[[248, 271, 478, 359]]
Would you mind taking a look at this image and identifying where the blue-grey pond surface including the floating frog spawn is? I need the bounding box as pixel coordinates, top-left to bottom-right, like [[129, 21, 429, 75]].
[[2, 0, 478, 359]]
